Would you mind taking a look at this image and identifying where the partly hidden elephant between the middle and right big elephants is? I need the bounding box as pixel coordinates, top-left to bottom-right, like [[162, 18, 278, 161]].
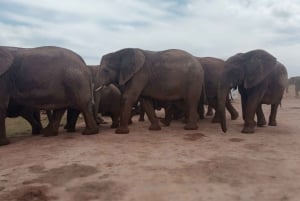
[[197, 57, 239, 123]]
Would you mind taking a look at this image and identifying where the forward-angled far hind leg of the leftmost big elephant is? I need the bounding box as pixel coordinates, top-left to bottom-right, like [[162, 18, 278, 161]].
[[42, 108, 66, 137]]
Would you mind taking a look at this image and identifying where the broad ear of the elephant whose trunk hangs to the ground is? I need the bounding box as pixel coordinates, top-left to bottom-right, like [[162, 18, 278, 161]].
[[243, 50, 277, 89]]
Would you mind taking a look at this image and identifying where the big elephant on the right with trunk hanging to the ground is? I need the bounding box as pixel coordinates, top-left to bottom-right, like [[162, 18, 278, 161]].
[[218, 50, 287, 133]]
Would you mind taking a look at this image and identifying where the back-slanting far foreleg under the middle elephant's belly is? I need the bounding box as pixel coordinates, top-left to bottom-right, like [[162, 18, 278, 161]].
[[141, 98, 161, 130]]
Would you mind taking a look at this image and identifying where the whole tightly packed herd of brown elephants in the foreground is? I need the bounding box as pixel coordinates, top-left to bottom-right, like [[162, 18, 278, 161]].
[[0, 46, 288, 145]]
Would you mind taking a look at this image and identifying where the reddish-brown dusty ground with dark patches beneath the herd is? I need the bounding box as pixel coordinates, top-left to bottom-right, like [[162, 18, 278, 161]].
[[0, 89, 300, 201]]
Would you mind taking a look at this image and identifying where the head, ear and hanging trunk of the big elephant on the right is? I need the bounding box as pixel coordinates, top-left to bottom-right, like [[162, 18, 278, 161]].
[[218, 50, 277, 132]]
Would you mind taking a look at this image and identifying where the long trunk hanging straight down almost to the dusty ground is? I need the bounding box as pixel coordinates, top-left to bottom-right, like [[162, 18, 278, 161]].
[[218, 85, 229, 133]]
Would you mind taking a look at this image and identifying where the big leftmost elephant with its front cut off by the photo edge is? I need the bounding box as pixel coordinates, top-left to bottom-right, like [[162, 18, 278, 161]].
[[0, 46, 98, 145]]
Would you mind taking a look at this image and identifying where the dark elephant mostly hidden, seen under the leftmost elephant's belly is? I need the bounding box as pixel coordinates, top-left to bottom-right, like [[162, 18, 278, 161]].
[[6, 99, 42, 135]]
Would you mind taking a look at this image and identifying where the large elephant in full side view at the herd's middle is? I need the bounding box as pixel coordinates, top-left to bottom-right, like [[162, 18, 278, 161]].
[[96, 48, 204, 133]]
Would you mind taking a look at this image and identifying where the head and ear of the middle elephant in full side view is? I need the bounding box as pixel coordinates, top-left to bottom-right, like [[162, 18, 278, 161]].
[[96, 48, 145, 87]]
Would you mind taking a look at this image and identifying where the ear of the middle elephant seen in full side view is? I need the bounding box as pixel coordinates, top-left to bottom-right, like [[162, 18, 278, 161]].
[[119, 48, 145, 85]]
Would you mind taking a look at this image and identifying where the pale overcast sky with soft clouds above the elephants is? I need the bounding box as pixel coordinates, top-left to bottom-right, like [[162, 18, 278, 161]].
[[0, 0, 300, 76]]
